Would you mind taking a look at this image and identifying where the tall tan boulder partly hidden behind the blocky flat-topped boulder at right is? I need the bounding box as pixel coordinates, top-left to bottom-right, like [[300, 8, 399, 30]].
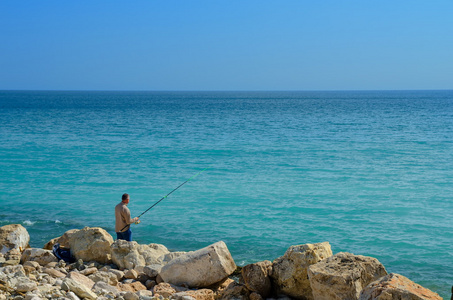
[[271, 242, 332, 300]]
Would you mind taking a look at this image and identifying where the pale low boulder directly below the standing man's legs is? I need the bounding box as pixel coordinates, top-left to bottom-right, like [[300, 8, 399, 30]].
[[111, 240, 170, 270]]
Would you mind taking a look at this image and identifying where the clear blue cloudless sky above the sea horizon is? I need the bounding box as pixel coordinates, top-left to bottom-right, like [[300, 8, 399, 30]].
[[0, 0, 453, 90]]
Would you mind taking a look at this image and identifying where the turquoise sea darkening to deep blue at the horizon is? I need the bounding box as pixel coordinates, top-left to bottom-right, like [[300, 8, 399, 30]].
[[0, 90, 453, 298]]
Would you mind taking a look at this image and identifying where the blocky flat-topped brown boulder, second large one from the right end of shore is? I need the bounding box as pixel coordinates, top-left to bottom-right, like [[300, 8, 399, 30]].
[[308, 252, 387, 300]]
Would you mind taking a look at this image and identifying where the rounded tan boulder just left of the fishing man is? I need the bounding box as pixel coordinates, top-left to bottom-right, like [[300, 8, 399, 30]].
[[69, 227, 113, 264]]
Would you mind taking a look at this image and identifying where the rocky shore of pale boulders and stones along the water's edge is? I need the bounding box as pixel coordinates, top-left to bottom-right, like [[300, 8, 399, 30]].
[[0, 224, 442, 300]]
